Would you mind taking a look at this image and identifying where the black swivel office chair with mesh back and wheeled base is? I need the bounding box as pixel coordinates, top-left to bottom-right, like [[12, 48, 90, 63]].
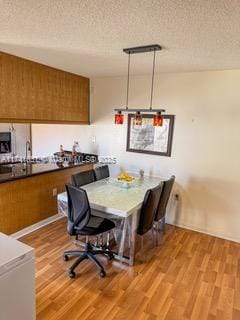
[[63, 184, 115, 278]]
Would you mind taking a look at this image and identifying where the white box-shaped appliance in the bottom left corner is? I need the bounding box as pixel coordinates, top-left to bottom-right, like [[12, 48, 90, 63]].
[[0, 233, 36, 320]]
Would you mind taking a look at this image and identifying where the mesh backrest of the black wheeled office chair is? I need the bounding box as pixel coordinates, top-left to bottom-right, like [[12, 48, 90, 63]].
[[66, 184, 91, 235]]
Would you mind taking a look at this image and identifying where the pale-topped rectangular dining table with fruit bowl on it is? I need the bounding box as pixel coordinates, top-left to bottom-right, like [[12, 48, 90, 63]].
[[57, 176, 162, 265]]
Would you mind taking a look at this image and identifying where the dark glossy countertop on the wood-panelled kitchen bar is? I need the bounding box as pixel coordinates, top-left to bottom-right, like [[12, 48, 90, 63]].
[[0, 162, 94, 183]]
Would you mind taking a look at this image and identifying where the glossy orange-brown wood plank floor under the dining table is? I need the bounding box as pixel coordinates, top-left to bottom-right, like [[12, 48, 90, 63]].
[[22, 220, 240, 320]]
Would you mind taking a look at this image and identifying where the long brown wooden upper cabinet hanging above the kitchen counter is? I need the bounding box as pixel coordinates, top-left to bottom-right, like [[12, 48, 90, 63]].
[[0, 52, 89, 124]]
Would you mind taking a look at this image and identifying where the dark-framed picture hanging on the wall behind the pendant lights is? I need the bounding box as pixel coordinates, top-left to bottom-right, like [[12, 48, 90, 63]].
[[126, 113, 175, 157]]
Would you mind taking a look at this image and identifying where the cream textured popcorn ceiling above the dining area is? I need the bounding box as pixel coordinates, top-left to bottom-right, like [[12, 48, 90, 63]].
[[0, 0, 240, 77]]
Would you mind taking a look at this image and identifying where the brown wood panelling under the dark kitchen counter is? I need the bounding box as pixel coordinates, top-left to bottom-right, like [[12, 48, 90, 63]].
[[0, 163, 93, 234]]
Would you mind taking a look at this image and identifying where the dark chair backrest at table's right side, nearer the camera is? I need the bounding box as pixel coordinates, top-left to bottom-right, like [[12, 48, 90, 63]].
[[137, 183, 163, 235]]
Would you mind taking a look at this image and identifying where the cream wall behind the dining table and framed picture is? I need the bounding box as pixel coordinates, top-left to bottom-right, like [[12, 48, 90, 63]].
[[33, 70, 240, 241]]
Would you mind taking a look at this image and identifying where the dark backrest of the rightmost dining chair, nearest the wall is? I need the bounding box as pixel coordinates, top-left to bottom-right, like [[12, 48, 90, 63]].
[[155, 176, 175, 232]]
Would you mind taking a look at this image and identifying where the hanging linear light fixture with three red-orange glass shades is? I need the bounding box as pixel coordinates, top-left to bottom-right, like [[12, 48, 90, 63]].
[[114, 44, 165, 126]]
